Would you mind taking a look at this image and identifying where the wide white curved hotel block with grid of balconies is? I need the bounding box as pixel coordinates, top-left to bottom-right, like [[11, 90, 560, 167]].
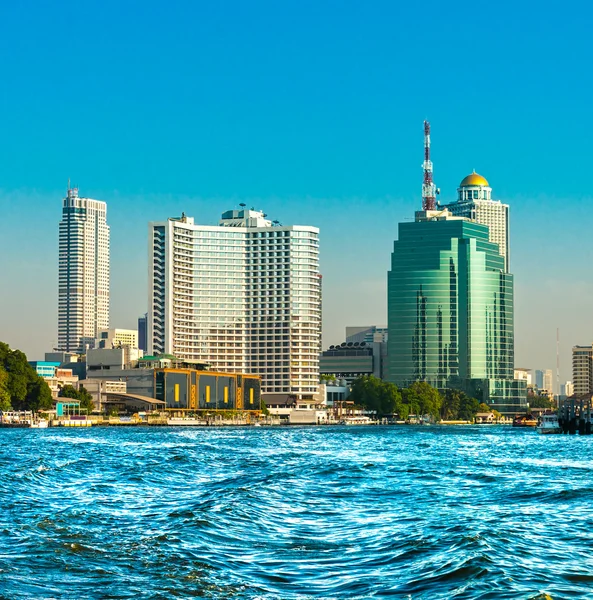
[[148, 209, 321, 398]]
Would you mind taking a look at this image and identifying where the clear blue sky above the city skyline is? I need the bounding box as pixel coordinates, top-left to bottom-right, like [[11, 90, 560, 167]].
[[0, 0, 593, 380]]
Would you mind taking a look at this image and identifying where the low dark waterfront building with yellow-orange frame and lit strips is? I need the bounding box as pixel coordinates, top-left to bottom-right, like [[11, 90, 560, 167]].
[[154, 369, 261, 412]]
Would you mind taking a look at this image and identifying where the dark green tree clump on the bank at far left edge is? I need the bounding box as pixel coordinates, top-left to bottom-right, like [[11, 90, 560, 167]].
[[0, 342, 52, 411]]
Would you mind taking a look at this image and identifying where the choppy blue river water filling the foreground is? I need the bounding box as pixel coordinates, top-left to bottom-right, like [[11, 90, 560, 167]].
[[0, 426, 593, 600]]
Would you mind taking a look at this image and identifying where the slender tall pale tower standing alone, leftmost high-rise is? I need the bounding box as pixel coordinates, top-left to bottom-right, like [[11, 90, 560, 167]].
[[58, 188, 109, 352]]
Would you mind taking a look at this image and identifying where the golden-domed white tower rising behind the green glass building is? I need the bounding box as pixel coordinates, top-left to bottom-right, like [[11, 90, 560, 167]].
[[442, 171, 510, 272]]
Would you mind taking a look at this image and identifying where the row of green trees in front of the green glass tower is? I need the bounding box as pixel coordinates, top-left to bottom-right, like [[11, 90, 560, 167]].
[[349, 375, 498, 421]]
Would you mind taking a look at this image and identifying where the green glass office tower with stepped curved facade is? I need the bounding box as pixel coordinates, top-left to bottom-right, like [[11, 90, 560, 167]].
[[387, 210, 527, 414]]
